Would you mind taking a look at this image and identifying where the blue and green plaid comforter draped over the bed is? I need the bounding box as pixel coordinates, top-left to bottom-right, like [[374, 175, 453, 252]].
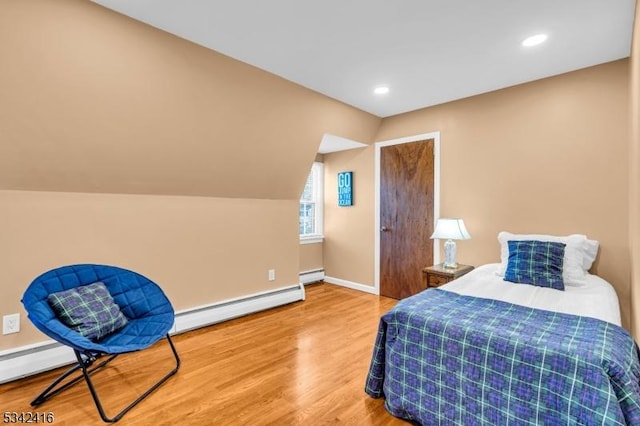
[[365, 289, 640, 425]]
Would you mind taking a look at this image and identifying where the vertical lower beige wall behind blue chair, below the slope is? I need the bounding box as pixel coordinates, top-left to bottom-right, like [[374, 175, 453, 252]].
[[0, 191, 298, 349]]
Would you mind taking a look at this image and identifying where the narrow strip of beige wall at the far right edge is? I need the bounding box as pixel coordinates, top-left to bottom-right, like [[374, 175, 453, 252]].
[[629, 2, 640, 341]]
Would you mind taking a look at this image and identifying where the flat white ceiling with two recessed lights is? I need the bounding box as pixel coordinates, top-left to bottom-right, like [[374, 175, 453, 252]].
[[93, 0, 635, 117]]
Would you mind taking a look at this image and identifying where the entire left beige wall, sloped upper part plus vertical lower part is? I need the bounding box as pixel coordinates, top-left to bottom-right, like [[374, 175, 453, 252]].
[[0, 0, 380, 350]]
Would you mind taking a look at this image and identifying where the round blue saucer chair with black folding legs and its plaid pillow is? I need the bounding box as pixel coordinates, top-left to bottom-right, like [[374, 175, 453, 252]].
[[22, 264, 180, 422]]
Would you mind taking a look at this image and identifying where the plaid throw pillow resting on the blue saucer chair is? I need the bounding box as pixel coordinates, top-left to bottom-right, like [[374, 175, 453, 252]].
[[47, 282, 127, 341]]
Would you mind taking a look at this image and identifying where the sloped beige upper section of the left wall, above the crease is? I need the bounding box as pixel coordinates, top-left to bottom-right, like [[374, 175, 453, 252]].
[[0, 0, 380, 199]]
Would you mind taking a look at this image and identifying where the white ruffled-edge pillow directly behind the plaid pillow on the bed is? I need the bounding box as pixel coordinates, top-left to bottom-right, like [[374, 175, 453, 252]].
[[497, 231, 597, 286]]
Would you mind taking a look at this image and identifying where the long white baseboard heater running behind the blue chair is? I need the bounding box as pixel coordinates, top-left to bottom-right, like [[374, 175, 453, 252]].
[[0, 284, 305, 383]]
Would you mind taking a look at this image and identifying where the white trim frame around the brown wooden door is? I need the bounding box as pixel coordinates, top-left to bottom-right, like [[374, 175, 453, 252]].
[[373, 132, 440, 295]]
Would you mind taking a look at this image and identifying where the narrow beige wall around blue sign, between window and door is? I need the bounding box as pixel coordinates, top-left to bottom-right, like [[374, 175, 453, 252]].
[[324, 146, 374, 286]]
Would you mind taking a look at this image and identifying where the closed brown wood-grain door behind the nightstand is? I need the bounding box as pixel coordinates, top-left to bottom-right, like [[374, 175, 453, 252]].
[[380, 139, 434, 299]]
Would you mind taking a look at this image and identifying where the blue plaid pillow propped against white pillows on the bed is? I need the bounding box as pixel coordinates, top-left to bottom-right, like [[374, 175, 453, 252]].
[[504, 241, 565, 290]]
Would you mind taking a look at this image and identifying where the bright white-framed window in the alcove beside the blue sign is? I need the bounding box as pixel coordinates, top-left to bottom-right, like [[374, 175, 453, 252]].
[[300, 163, 324, 243]]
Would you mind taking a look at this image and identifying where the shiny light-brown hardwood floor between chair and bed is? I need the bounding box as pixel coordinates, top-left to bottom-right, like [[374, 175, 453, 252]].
[[0, 284, 408, 425]]
